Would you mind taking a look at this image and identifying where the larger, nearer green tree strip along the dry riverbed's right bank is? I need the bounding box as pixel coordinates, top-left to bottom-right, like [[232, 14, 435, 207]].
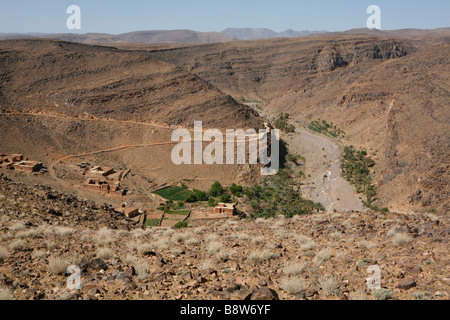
[[341, 146, 378, 210]]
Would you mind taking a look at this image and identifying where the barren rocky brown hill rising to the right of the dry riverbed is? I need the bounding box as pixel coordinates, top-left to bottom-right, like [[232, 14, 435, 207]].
[[147, 35, 449, 211]]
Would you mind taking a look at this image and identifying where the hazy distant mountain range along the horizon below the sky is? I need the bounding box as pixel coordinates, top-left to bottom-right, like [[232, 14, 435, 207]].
[[0, 28, 450, 44]]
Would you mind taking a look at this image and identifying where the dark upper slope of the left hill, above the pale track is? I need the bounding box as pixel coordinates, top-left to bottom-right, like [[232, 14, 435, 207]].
[[0, 40, 261, 128]]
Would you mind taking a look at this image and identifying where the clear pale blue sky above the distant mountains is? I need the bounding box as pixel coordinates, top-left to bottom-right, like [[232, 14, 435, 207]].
[[0, 0, 450, 34]]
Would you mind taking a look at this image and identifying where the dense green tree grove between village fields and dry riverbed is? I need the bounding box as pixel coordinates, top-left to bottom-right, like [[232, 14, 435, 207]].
[[244, 169, 325, 218]]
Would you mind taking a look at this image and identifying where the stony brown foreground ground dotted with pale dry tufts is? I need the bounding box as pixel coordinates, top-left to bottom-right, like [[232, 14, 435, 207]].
[[0, 177, 450, 300]]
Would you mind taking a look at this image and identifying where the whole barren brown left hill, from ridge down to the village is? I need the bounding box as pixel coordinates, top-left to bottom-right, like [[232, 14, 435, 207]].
[[0, 40, 263, 198]]
